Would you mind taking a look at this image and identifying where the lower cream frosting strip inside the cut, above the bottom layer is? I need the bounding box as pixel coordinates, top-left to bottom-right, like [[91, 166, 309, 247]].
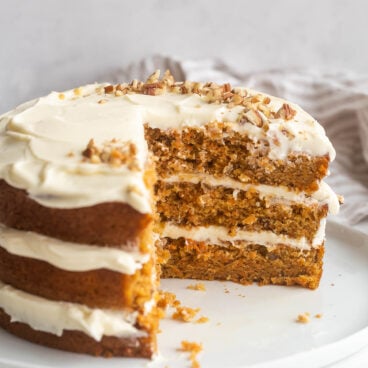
[[161, 219, 326, 250]]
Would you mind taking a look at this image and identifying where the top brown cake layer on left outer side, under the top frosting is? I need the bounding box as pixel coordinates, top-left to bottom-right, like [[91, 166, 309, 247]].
[[0, 180, 152, 248]]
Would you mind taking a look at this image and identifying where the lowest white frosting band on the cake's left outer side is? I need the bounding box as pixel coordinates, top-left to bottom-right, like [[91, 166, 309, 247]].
[[0, 281, 145, 341]]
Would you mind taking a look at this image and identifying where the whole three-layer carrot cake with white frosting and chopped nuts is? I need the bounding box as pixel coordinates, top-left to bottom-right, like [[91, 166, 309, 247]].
[[0, 72, 339, 357]]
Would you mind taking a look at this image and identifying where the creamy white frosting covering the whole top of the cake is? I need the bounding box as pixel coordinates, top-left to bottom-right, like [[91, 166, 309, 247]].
[[0, 85, 335, 213]]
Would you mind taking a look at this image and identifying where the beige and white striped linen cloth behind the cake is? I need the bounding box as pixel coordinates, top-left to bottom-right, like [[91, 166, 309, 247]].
[[108, 56, 368, 224]]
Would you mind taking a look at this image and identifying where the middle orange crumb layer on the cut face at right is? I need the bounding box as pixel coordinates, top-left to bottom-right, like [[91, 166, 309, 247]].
[[156, 181, 328, 241]]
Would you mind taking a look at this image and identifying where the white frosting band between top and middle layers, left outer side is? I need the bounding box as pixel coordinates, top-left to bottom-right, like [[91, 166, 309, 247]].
[[0, 224, 150, 275]]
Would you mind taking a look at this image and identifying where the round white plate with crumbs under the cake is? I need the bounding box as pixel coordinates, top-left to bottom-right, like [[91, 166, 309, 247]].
[[0, 223, 368, 368]]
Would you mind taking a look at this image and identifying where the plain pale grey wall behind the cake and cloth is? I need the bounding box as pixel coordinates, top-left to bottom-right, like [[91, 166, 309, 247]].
[[0, 0, 368, 368]]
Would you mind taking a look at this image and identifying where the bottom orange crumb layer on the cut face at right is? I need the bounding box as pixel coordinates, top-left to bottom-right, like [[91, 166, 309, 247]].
[[159, 238, 324, 289]]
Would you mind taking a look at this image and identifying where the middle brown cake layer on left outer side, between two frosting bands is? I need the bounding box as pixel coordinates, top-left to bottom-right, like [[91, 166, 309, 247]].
[[0, 247, 156, 310]]
